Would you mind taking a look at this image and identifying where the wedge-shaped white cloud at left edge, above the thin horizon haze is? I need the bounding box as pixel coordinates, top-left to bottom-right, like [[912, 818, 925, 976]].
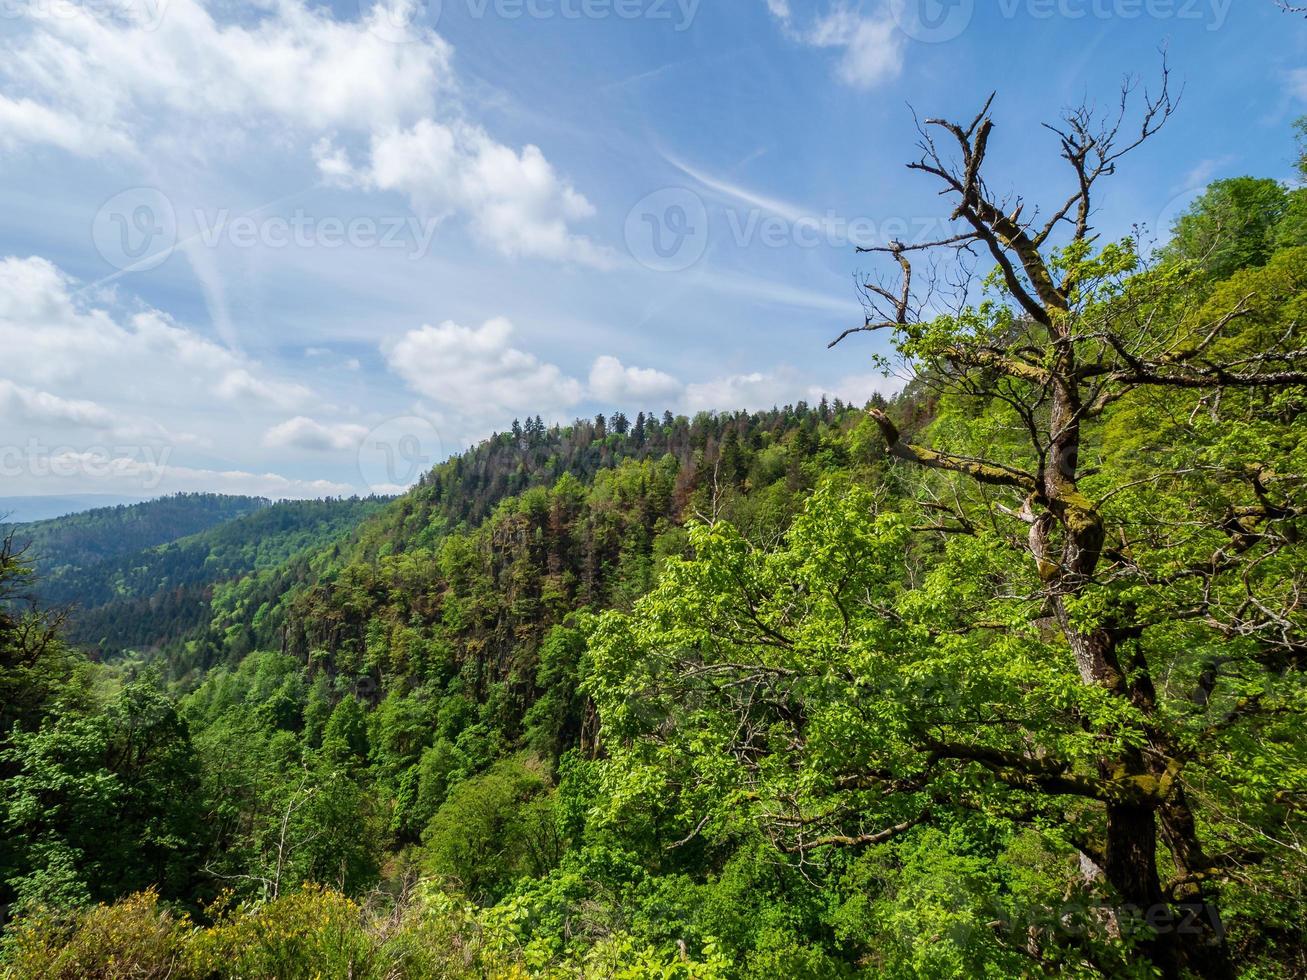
[[0, 249, 355, 493]]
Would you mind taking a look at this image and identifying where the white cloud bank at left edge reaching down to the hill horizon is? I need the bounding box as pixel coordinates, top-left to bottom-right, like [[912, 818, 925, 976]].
[[0, 256, 366, 497]]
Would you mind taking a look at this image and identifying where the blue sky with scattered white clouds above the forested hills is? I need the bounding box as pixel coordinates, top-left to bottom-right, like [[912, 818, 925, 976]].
[[0, 0, 1307, 497]]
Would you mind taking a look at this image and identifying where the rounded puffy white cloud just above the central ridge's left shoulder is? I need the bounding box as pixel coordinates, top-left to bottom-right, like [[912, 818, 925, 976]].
[[383, 318, 584, 439]]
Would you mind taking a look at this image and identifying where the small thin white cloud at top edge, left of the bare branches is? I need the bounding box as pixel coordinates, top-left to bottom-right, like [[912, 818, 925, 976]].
[[766, 0, 907, 89]]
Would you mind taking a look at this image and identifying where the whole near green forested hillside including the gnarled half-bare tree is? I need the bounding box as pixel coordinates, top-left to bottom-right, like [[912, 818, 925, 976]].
[[0, 88, 1307, 980]]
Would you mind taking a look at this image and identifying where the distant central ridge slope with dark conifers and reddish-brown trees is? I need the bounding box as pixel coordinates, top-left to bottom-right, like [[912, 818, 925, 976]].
[[178, 401, 883, 679]]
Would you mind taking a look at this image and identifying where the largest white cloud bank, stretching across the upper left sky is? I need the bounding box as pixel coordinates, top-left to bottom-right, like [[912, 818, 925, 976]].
[[0, 0, 610, 265]]
